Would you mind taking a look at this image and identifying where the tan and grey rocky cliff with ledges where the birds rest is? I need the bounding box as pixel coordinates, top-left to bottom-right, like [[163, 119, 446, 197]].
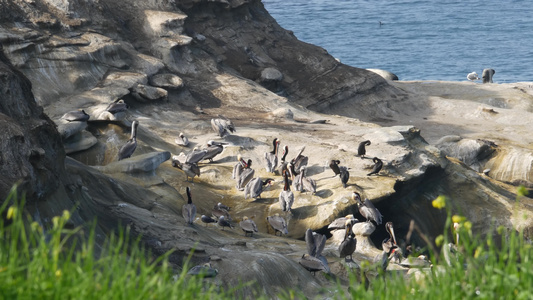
[[0, 0, 532, 295]]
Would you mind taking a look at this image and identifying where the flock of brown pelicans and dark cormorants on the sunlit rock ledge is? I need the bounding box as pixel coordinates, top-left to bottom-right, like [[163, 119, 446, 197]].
[[62, 106, 428, 275]]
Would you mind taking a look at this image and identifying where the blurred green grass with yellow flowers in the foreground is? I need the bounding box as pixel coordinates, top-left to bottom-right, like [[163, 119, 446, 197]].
[[0, 189, 533, 299]]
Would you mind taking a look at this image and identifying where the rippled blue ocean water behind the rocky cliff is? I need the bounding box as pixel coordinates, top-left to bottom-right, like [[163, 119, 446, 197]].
[[263, 0, 533, 83]]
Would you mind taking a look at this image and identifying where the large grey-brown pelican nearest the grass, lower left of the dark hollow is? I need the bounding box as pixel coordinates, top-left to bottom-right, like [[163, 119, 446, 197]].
[[298, 228, 330, 275]]
